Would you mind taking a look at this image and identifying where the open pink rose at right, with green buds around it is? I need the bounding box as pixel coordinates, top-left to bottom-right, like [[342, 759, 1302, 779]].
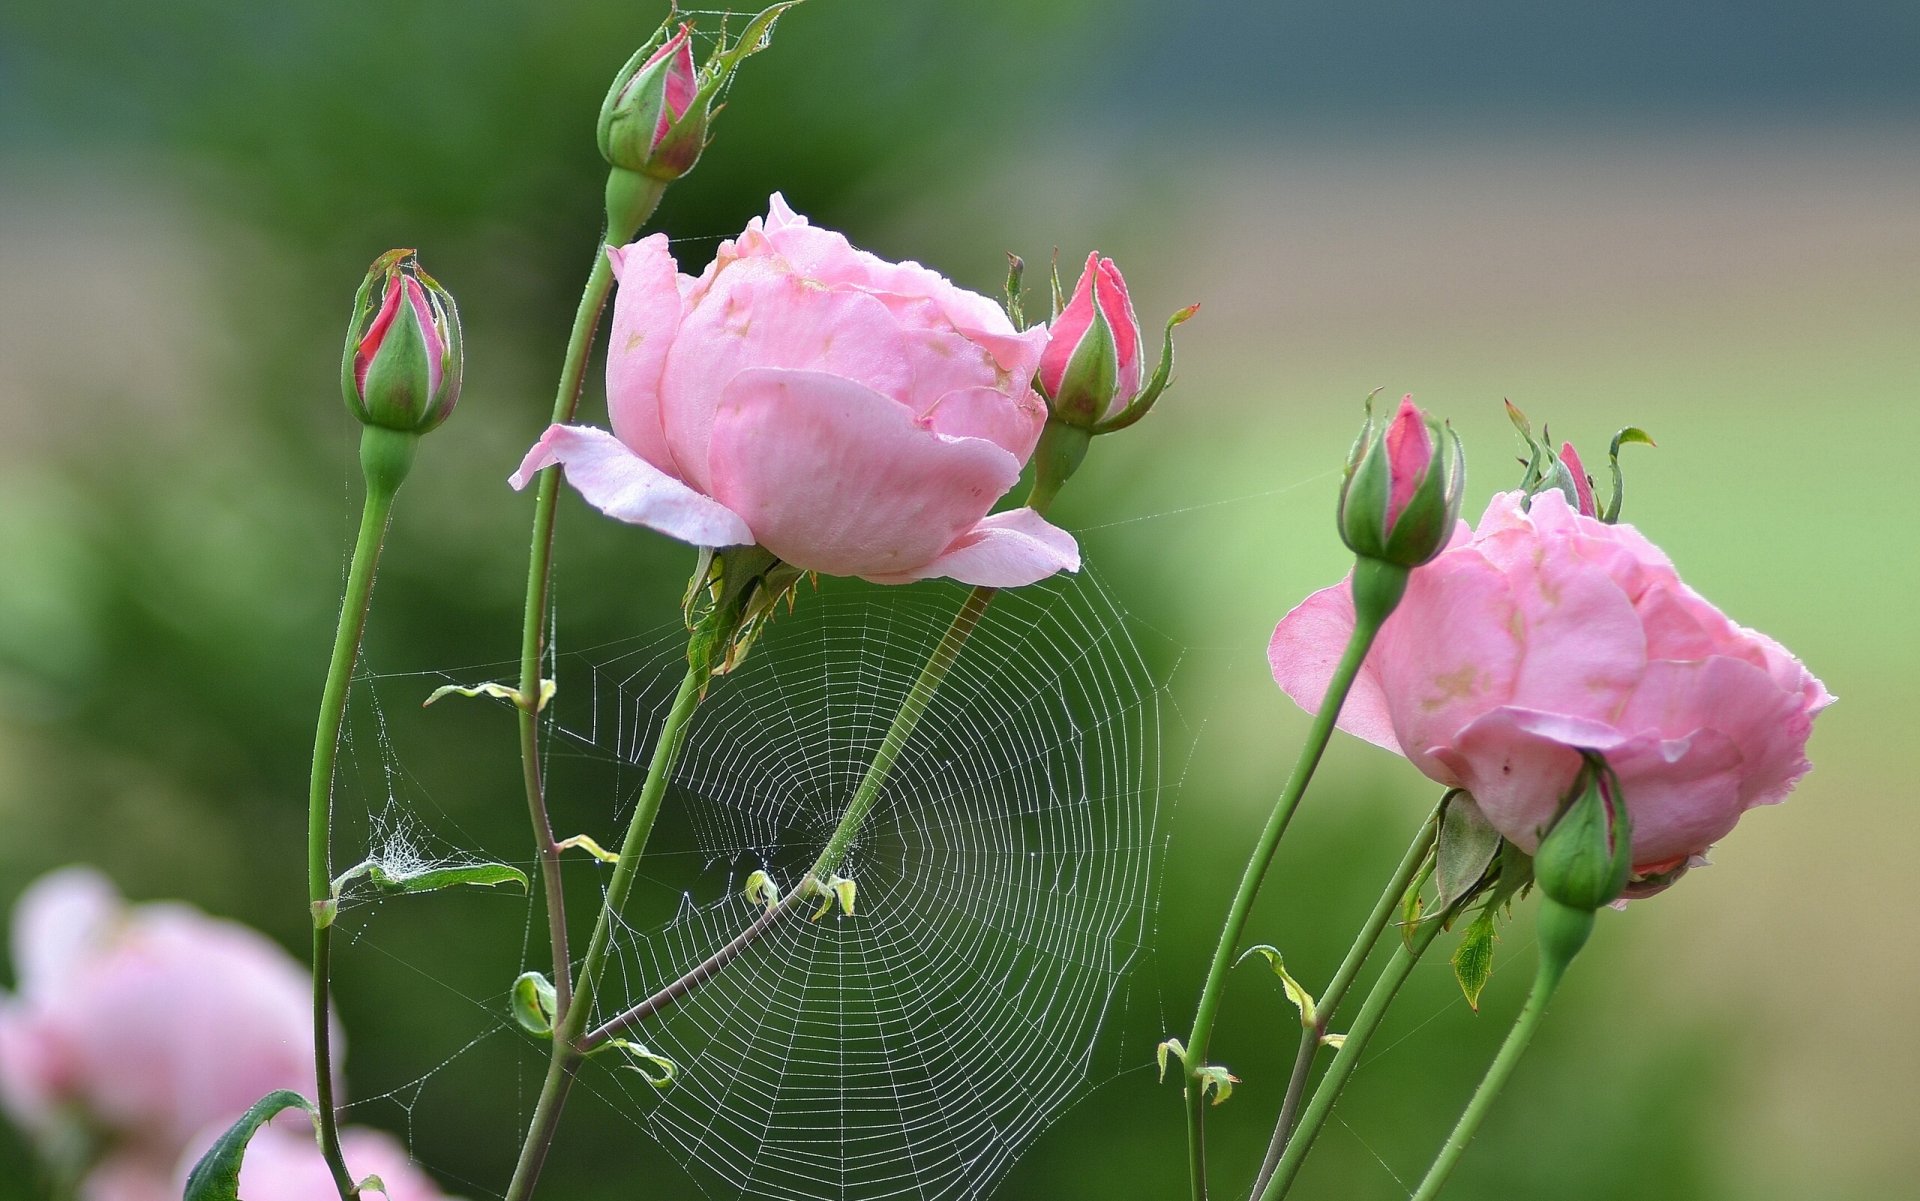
[[1267, 489, 1834, 877]]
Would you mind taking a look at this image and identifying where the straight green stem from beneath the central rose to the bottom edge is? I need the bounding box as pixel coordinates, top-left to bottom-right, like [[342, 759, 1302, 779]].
[[507, 610, 722, 1201]]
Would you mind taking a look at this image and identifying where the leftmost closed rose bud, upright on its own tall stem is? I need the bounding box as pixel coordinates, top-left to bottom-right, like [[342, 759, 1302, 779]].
[[340, 249, 461, 434]]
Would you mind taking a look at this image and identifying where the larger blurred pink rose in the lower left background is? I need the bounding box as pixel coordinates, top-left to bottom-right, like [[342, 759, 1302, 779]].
[[0, 867, 322, 1166]]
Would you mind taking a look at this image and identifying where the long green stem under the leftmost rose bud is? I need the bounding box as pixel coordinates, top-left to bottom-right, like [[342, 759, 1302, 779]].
[[307, 426, 417, 1201]]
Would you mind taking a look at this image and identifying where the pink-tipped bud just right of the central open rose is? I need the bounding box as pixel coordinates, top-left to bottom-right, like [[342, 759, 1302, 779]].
[[1041, 251, 1142, 426]]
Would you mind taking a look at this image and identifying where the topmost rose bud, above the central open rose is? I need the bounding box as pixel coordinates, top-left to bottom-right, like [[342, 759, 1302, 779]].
[[597, 25, 707, 180]]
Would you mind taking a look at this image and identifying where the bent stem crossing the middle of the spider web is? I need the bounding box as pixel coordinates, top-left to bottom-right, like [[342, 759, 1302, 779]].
[[580, 587, 995, 1051]]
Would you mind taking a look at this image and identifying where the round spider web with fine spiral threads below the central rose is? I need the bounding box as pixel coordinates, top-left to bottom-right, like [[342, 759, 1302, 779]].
[[503, 576, 1164, 1201]]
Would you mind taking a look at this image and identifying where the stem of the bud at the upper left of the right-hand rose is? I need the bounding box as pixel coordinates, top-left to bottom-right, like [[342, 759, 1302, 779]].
[[1185, 558, 1407, 1201]]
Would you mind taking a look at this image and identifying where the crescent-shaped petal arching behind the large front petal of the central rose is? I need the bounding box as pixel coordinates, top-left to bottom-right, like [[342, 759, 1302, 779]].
[[660, 259, 913, 495]]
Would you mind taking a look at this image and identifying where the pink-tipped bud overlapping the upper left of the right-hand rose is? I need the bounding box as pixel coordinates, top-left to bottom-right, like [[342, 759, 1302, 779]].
[[1340, 395, 1467, 568]]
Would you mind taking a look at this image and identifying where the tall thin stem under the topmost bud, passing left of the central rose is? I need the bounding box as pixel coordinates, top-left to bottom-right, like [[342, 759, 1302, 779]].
[[518, 169, 666, 1017]]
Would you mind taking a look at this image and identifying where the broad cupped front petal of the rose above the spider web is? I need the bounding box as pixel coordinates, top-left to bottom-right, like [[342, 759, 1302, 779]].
[[712, 368, 1020, 577]]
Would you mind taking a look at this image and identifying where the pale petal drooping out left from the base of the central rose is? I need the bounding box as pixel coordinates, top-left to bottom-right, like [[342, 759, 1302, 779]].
[[509, 426, 755, 547]]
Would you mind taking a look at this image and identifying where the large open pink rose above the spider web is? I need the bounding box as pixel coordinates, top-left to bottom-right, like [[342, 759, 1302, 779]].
[[513, 196, 1079, 587]]
